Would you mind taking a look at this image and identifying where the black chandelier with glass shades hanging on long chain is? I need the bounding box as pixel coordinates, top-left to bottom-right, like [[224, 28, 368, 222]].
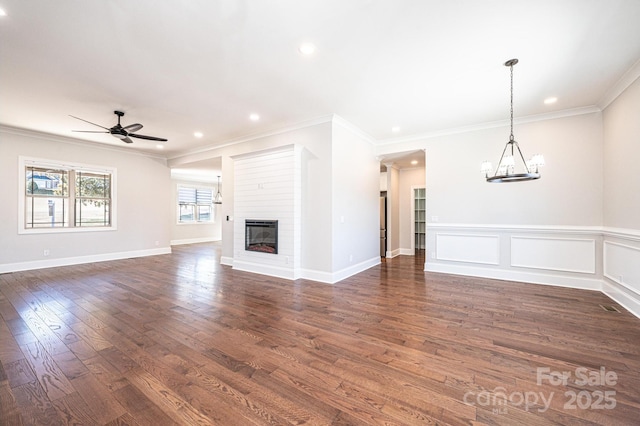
[[480, 59, 544, 183]]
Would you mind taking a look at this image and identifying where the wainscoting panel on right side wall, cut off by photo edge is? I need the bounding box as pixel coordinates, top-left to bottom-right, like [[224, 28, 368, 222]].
[[603, 241, 640, 295]]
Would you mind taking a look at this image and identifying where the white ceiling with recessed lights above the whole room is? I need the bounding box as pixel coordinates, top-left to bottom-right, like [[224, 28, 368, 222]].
[[0, 0, 640, 158]]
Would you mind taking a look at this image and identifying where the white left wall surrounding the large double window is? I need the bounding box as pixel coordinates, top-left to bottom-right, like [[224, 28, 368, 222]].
[[0, 128, 171, 272]]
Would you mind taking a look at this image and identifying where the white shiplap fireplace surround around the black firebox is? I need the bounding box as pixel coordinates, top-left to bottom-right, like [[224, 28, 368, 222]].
[[233, 145, 302, 280]]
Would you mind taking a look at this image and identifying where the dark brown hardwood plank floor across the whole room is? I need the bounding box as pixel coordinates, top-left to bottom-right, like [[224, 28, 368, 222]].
[[0, 244, 640, 426]]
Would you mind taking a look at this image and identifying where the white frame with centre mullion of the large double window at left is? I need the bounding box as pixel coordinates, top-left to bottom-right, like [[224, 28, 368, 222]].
[[18, 156, 118, 234]]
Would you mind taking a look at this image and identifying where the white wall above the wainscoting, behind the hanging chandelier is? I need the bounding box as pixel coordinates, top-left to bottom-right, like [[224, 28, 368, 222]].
[[423, 113, 603, 226]]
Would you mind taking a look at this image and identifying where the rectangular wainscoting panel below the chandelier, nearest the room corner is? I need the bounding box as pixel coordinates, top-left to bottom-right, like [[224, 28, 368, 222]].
[[511, 236, 596, 274]]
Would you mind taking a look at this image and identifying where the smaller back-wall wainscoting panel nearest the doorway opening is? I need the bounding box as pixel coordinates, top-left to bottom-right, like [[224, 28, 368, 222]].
[[435, 233, 500, 265]]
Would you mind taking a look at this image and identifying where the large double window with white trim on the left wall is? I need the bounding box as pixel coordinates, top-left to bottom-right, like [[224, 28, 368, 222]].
[[19, 157, 115, 233]]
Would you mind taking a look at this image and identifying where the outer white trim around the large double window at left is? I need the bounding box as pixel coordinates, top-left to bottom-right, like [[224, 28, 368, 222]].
[[18, 156, 118, 234]]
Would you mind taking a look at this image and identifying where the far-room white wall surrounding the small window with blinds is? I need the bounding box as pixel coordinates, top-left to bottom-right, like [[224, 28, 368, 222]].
[[169, 179, 222, 245]]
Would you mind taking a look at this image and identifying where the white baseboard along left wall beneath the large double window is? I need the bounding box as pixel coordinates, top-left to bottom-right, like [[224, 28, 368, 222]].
[[0, 247, 171, 274]]
